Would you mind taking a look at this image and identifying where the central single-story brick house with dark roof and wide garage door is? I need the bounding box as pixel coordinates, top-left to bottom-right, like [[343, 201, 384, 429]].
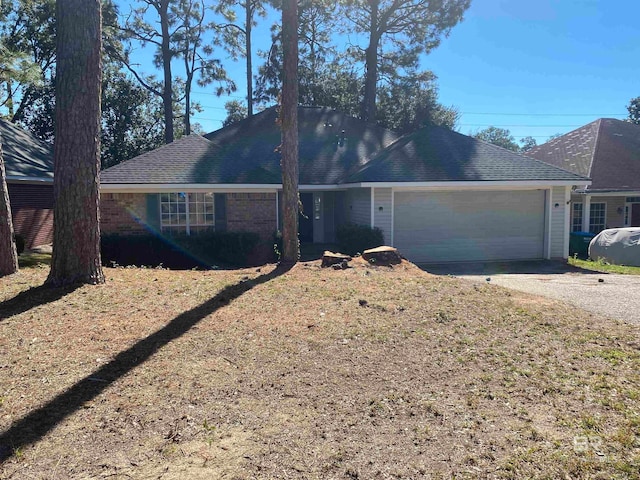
[[100, 107, 589, 263]]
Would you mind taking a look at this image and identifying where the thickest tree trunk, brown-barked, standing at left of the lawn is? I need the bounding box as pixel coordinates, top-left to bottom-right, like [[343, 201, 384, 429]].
[[47, 0, 104, 286]]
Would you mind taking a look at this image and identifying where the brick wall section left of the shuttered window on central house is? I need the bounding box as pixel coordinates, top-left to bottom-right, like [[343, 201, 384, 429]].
[[100, 193, 147, 235]]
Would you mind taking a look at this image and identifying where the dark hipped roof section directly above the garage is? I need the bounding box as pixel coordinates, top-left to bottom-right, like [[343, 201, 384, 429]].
[[347, 127, 586, 183]]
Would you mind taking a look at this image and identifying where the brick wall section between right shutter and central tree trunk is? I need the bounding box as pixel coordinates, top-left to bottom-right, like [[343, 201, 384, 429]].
[[227, 189, 276, 240]]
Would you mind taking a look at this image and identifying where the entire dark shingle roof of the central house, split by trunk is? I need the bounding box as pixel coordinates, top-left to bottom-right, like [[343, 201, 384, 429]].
[[100, 107, 586, 185]]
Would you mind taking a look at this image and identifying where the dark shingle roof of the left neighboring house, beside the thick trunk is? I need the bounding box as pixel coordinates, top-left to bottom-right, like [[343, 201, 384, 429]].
[[0, 119, 53, 179]]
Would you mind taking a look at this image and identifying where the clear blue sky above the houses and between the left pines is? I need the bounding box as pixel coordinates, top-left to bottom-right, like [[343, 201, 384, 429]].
[[138, 0, 640, 143]]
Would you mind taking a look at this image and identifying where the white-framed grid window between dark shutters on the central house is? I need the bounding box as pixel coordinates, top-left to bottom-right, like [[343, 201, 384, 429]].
[[160, 192, 215, 235]]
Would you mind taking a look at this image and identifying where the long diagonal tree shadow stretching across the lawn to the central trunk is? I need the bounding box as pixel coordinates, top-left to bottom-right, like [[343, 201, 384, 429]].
[[0, 260, 291, 464]]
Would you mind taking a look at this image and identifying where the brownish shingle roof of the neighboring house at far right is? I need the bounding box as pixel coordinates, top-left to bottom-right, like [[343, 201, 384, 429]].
[[527, 118, 640, 190]]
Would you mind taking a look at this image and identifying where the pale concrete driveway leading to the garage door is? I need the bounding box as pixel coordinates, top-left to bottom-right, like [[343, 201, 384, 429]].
[[421, 261, 640, 324]]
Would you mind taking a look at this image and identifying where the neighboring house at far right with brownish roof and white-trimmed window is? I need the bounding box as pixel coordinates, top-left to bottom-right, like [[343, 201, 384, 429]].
[[527, 118, 640, 233]]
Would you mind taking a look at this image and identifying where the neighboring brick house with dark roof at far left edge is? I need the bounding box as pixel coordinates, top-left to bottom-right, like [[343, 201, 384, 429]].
[[0, 119, 53, 248]]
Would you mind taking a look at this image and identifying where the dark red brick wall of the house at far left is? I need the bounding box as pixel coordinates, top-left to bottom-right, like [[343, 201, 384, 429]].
[[7, 183, 53, 248]]
